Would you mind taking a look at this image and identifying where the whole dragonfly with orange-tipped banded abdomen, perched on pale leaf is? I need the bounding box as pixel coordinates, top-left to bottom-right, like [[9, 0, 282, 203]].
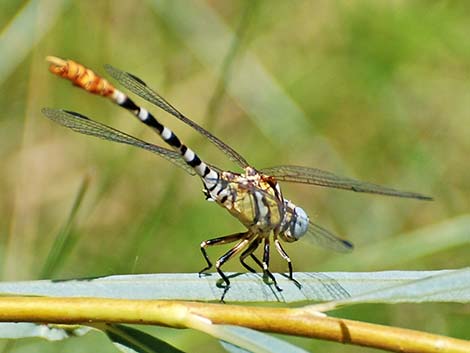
[[42, 56, 432, 298]]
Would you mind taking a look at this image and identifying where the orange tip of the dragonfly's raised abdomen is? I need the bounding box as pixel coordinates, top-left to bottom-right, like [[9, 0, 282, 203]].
[[46, 56, 115, 97]]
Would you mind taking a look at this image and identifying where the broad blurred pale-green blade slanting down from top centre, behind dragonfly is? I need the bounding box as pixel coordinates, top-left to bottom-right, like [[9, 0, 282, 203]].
[[147, 0, 316, 146]]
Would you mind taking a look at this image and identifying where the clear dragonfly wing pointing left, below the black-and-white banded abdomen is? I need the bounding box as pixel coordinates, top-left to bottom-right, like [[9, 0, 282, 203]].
[[41, 108, 196, 175]]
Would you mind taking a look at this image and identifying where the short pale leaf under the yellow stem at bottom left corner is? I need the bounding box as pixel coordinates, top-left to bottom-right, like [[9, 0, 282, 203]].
[[0, 322, 90, 341]]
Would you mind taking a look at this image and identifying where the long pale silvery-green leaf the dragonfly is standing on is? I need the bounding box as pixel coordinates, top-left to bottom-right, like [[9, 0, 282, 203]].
[[0, 269, 470, 303]]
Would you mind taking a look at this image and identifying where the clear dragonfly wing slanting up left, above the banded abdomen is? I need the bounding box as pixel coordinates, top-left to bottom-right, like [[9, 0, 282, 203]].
[[105, 65, 249, 168]]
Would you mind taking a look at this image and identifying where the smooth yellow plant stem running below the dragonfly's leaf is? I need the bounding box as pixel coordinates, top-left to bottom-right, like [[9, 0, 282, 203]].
[[0, 297, 470, 353]]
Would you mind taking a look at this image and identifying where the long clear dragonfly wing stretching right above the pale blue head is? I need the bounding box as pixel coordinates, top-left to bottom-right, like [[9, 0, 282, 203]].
[[261, 165, 432, 200]]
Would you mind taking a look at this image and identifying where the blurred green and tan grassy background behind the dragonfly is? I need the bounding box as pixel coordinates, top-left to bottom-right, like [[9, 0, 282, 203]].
[[0, 0, 470, 352]]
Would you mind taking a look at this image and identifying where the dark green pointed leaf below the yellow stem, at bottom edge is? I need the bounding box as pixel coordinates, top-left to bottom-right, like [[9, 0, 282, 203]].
[[101, 324, 183, 353]]
